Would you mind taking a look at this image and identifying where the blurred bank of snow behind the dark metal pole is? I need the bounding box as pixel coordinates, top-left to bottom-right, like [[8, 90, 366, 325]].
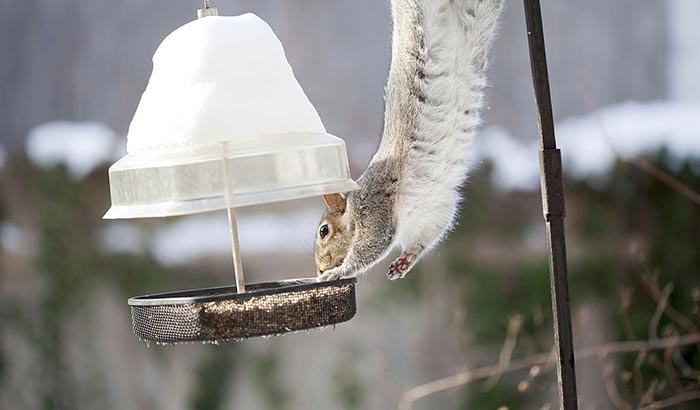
[[477, 101, 700, 191]]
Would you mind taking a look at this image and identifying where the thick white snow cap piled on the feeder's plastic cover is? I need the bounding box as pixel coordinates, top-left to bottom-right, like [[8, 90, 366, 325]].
[[127, 13, 326, 153]]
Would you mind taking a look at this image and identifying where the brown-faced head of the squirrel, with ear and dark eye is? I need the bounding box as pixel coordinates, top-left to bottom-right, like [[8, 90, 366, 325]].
[[314, 194, 355, 275]]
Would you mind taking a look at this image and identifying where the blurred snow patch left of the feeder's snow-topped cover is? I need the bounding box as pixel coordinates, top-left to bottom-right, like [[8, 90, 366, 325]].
[[26, 121, 123, 179]]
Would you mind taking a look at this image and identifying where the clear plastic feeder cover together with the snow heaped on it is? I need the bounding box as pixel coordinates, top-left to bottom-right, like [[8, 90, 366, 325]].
[[105, 14, 357, 219]]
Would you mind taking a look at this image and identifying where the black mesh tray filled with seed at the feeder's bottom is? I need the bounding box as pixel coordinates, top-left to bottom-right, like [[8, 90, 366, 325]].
[[129, 278, 356, 343]]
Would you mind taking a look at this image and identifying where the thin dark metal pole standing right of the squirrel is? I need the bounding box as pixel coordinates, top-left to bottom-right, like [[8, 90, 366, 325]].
[[524, 0, 578, 410]]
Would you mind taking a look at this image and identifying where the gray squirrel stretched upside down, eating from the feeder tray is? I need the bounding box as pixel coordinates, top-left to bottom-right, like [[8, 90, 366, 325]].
[[314, 0, 502, 281]]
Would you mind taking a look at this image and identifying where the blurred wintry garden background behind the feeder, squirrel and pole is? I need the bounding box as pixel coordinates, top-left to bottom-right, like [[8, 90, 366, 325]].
[[0, 0, 700, 410]]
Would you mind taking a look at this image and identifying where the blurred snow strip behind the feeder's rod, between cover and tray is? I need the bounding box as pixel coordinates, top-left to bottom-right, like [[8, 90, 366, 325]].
[[151, 205, 323, 266]]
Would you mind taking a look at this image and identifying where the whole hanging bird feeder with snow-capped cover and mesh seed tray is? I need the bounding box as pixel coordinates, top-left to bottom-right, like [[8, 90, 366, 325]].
[[104, 2, 358, 343]]
